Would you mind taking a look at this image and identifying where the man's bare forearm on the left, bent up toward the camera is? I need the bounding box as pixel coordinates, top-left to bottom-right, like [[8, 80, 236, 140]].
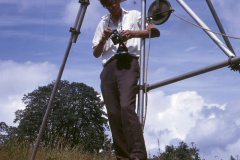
[[93, 27, 112, 58]]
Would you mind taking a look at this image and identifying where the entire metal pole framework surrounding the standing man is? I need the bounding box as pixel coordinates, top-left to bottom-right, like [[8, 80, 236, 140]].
[[31, 0, 240, 160]]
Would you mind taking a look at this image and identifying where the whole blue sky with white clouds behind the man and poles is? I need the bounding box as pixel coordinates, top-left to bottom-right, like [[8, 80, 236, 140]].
[[0, 0, 240, 160]]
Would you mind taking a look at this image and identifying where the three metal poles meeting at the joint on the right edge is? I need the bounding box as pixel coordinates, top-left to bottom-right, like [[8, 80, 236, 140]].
[[147, 0, 240, 91]]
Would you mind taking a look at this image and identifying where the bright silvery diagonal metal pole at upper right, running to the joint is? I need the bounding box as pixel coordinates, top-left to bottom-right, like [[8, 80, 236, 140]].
[[177, 0, 235, 57]]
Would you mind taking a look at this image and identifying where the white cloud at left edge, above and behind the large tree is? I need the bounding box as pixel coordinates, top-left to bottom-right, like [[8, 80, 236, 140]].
[[0, 60, 57, 125]]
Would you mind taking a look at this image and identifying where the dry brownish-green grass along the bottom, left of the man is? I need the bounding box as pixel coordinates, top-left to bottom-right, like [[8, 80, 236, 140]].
[[0, 140, 116, 160]]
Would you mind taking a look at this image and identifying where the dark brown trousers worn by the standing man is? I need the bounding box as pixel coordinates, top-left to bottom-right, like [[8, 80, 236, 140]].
[[100, 56, 147, 160]]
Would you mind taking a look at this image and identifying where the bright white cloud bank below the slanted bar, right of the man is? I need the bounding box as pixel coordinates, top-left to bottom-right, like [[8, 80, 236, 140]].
[[144, 91, 240, 159]]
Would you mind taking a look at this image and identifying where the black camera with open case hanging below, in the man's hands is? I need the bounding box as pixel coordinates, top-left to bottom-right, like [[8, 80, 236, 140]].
[[111, 29, 129, 55]]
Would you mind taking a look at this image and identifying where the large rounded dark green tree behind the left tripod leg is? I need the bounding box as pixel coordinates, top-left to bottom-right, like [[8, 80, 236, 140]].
[[14, 80, 108, 152]]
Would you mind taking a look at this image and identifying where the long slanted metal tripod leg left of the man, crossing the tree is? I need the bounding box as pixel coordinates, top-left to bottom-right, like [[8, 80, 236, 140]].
[[31, 0, 90, 160]]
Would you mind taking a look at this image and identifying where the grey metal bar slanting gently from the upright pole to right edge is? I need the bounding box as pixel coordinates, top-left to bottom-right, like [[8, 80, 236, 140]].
[[147, 56, 240, 91]]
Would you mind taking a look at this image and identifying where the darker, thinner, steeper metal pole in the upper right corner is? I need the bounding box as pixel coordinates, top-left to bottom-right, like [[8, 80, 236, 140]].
[[206, 0, 236, 56]]
